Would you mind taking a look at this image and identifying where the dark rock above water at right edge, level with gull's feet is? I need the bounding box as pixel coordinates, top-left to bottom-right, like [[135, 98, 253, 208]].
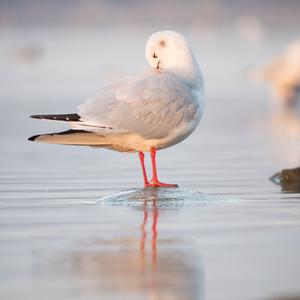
[[270, 167, 300, 193]]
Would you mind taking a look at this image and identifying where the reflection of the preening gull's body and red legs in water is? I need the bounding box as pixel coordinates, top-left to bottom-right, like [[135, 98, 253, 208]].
[[59, 189, 204, 300]]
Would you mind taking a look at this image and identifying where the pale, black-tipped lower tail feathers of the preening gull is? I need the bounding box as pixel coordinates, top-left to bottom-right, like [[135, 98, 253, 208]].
[[28, 129, 109, 147]]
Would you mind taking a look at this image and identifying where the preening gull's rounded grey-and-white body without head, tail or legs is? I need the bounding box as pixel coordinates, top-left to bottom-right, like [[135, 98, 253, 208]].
[[76, 71, 202, 151]]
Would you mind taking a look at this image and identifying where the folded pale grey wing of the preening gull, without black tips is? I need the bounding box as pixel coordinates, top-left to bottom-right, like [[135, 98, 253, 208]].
[[79, 74, 199, 139]]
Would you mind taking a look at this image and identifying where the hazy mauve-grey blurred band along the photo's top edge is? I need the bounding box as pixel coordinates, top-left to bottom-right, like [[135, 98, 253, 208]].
[[0, 0, 300, 30]]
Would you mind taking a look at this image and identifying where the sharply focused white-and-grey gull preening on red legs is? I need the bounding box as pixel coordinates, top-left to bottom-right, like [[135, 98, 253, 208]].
[[29, 31, 204, 187]]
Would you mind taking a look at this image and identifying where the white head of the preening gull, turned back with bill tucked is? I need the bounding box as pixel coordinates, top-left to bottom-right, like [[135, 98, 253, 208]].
[[145, 31, 203, 86]]
